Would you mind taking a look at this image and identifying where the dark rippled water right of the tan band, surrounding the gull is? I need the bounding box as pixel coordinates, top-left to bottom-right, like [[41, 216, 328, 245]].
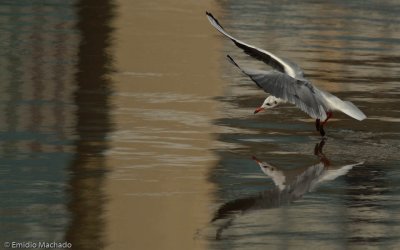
[[210, 1, 400, 249]]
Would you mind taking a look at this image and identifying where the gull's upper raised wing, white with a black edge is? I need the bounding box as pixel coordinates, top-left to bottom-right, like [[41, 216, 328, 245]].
[[206, 12, 303, 79]]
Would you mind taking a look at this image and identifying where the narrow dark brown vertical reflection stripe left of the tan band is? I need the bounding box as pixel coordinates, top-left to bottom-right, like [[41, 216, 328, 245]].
[[65, 0, 115, 249]]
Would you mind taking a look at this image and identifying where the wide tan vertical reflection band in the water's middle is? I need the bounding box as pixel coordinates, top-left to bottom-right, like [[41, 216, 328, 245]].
[[105, 0, 223, 249]]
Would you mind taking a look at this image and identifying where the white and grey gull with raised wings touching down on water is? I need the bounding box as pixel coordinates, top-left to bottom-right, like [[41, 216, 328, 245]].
[[206, 12, 366, 136]]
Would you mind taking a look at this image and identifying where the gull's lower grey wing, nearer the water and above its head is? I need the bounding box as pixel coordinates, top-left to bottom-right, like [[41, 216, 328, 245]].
[[228, 55, 326, 120]]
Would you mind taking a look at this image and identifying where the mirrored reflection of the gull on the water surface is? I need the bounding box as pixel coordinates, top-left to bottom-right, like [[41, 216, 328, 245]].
[[212, 140, 362, 239]]
